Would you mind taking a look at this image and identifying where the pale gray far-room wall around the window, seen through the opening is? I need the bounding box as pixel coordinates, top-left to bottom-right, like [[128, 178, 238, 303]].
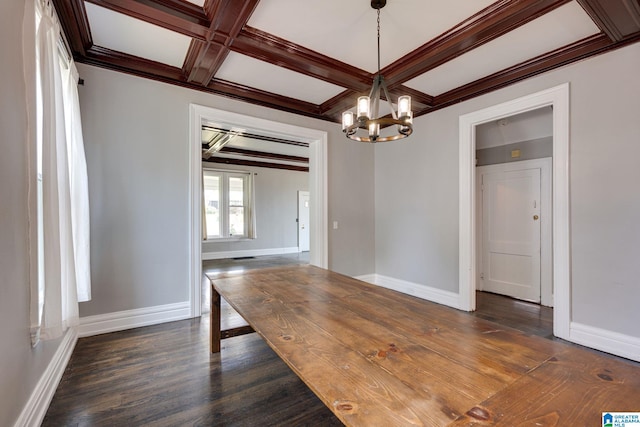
[[202, 162, 309, 254]]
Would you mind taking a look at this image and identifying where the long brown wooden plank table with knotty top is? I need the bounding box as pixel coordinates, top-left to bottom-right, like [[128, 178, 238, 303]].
[[211, 266, 640, 426]]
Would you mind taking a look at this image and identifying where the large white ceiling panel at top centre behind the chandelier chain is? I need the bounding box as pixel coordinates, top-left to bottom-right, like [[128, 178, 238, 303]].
[[248, 0, 493, 73]]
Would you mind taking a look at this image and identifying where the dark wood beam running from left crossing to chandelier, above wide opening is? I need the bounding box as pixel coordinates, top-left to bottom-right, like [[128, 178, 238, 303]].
[[230, 26, 373, 91]]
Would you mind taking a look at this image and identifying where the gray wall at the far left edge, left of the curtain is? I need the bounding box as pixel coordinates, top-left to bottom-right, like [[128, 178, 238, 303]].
[[0, 0, 65, 426]]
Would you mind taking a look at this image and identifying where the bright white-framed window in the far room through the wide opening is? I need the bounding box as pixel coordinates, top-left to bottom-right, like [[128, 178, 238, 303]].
[[202, 169, 255, 239]]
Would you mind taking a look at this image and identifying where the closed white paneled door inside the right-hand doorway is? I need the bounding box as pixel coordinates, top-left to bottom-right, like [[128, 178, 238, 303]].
[[481, 169, 540, 302]]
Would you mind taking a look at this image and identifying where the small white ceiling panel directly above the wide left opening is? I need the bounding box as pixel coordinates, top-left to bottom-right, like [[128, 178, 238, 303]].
[[216, 52, 344, 104]]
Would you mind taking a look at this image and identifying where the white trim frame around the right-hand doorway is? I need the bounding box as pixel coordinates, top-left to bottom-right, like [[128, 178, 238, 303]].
[[459, 84, 571, 339]]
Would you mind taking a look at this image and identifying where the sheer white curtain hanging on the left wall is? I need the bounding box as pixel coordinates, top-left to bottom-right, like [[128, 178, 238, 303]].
[[32, 0, 91, 343]]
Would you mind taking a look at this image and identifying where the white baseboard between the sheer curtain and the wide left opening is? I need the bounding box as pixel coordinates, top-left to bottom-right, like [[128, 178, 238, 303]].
[[78, 301, 191, 337]]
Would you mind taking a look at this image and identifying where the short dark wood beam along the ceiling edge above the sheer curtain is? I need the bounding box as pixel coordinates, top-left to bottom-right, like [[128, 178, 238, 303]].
[[53, 0, 93, 56]]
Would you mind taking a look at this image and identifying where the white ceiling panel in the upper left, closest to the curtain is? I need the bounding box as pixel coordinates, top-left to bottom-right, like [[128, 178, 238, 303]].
[[85, 2, 191, 68]]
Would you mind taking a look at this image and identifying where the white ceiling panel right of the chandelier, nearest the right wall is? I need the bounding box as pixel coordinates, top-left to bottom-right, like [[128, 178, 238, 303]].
[[405, 1, 600, 95]]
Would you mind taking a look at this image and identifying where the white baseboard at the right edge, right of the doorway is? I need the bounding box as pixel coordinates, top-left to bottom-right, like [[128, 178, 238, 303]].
[[569, 322, 640, 362]]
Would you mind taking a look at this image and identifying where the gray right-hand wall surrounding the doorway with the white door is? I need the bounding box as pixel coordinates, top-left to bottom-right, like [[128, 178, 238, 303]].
[[375, 43, 640, 337]]
